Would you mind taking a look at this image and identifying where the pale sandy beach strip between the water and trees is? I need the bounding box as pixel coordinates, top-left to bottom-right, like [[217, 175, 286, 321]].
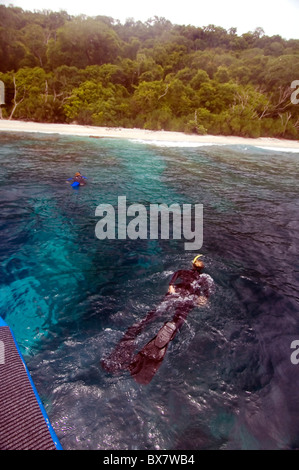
[[0, 119, 299, 152]]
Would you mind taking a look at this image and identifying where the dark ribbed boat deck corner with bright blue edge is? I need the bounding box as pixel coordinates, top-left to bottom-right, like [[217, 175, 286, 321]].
[[0, 318, 61, 450]]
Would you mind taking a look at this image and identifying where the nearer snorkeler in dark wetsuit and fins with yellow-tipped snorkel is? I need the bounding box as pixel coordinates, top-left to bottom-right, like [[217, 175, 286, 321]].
[[102, 255, 214, 385]]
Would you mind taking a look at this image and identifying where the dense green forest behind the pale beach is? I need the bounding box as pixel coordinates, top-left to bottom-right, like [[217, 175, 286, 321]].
[[0, 5, 299, 139]]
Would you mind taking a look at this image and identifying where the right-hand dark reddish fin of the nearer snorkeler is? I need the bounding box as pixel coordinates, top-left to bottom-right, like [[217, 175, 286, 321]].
[[129, 322, 176, 385]]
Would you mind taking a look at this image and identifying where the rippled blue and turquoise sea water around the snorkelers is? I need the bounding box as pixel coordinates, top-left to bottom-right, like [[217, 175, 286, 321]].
[[0, 133, 299, 450]]
